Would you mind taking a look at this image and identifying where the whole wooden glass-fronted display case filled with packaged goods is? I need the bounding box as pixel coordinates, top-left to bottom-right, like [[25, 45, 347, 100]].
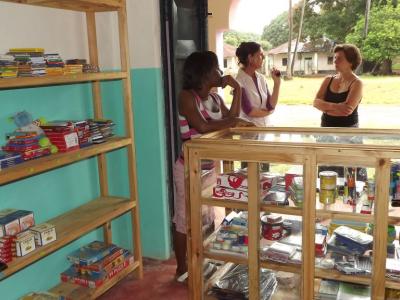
[[184, 128, 400, 300]]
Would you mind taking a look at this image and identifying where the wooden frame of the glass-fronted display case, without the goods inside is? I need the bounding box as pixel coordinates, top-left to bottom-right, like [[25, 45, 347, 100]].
[[184, 128, 400, 300]]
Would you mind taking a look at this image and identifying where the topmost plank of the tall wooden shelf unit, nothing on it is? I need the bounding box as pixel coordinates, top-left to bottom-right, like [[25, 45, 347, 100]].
[[1, 0, 124, 12]]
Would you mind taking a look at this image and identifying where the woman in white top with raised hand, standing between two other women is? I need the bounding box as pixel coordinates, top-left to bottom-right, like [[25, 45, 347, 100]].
[[236, 42, 281, 127]]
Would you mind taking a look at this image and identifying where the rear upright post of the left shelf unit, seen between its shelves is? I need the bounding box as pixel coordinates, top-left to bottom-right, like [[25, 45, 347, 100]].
[[86, 12, 112, 244]]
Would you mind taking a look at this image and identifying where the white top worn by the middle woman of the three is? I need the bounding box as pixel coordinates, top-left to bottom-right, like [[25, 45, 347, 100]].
[[236, 69, 272, 127]]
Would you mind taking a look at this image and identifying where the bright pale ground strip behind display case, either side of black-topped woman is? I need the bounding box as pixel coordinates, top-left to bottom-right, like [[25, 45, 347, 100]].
[[272, 101, 400, 129]]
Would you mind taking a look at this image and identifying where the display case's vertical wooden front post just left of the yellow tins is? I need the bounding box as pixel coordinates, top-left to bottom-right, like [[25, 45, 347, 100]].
[[301, 154, 317, 300]]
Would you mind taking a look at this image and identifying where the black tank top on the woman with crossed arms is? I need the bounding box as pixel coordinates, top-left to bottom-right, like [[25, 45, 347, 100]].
[[321, 76, 358, 127]]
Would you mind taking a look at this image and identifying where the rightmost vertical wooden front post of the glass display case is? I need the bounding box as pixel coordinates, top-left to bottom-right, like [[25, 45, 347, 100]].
[[371, 159, 390, 300]]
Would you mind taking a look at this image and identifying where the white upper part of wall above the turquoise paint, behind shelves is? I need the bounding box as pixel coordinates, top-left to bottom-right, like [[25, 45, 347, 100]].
[[0, 0, 161, 69]]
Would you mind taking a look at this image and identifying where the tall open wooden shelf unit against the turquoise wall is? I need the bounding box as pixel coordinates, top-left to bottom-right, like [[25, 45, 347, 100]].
[[0, 0, 143, 299]]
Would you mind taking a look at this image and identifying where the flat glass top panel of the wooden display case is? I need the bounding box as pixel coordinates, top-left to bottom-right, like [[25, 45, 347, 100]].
[[214, 131, 400, 146]]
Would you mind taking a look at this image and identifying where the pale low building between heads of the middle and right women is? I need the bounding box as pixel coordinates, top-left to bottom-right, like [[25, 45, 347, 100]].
[[267, 38, 335, 75]]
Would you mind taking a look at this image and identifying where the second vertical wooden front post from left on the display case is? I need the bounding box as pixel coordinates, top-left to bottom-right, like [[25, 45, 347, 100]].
[[247, 162, 260, 300]]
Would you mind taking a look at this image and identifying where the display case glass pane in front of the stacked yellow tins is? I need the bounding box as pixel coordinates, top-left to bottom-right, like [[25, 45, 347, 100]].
[[316, 165, 375, 214]]
